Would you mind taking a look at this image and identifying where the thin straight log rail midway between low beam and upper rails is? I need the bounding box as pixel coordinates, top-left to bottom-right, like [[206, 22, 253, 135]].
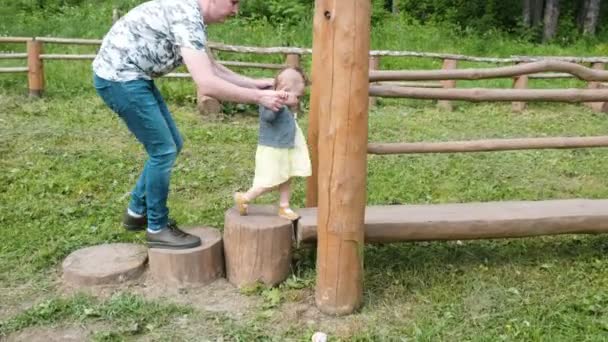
[[367, 136, 608, 154]]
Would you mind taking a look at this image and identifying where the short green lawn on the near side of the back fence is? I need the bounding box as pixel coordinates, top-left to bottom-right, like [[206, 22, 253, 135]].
[[0, 94, 608, 341]]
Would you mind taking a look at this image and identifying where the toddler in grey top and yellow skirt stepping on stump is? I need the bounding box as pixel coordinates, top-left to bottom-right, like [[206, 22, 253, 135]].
[[234, 67, 312, 221]]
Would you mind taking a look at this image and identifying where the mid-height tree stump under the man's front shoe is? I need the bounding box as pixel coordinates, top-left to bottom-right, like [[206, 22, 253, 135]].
[[148, 227, 224, 287]]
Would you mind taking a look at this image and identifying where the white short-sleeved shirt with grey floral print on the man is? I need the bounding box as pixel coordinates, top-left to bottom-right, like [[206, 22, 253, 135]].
[[93, 0, 207, 82]]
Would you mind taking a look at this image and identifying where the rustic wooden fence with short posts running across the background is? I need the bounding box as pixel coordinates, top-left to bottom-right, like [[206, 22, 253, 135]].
[[0, 37, 608, 112]]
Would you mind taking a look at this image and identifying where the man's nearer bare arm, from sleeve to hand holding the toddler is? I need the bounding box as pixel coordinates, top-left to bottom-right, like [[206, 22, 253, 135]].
[[181, 48, 286, 110]]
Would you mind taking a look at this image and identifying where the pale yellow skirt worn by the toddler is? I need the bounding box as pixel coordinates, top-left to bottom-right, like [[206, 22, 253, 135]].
[[253, 122, 312, 188]]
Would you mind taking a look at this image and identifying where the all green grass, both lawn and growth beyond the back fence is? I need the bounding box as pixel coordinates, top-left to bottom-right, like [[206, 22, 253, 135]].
[[0, 3, 608, 341]]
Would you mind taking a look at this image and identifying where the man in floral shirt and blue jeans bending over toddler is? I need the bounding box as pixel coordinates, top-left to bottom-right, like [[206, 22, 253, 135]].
[[93, 0, 287, 249]]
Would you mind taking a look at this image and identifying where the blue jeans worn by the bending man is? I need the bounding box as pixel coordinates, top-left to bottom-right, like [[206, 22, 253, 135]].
[[93, 75, 183, 230]]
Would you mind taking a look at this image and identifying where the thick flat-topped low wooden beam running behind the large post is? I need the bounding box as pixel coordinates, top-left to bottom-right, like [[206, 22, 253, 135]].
[[297, 199, 608, 243]]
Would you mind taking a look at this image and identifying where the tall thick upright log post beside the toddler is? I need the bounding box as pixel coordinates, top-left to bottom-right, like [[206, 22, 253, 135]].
[[312, 0, 371, 315]]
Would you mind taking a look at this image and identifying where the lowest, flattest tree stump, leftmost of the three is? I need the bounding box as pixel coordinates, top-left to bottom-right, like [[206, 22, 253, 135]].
[[62, 243, 148, 286]]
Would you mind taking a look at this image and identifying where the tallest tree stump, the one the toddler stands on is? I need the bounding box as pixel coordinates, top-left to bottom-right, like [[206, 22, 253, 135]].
[[224, 205, 293, 287]]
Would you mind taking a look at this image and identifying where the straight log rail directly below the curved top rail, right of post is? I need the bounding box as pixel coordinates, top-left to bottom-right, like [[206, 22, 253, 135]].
[[369, 85, 608, 103]]
